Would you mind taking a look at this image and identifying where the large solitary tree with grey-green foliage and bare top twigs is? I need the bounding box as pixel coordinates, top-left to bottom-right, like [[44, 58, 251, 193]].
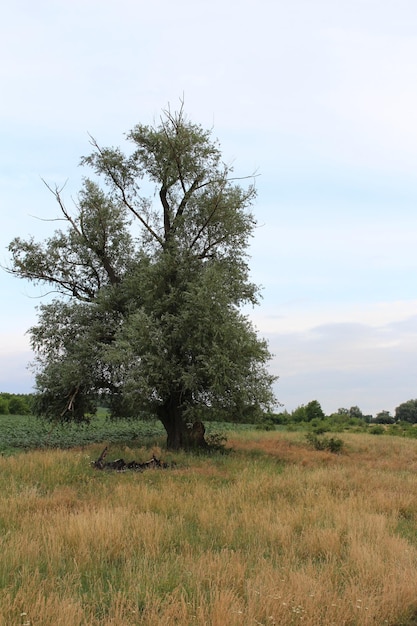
[[9, 107, 275, 449]]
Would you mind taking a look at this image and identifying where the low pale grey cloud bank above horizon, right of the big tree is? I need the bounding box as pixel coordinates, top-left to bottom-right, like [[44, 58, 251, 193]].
[[268, 309, 417, 415]]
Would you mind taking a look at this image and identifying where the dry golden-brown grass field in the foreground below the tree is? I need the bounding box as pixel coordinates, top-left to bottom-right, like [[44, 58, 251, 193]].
[[0, 418, 417, 626]]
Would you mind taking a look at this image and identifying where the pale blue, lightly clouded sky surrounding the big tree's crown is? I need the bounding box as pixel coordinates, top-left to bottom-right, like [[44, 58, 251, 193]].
[[0, 0, 417, 415]]
